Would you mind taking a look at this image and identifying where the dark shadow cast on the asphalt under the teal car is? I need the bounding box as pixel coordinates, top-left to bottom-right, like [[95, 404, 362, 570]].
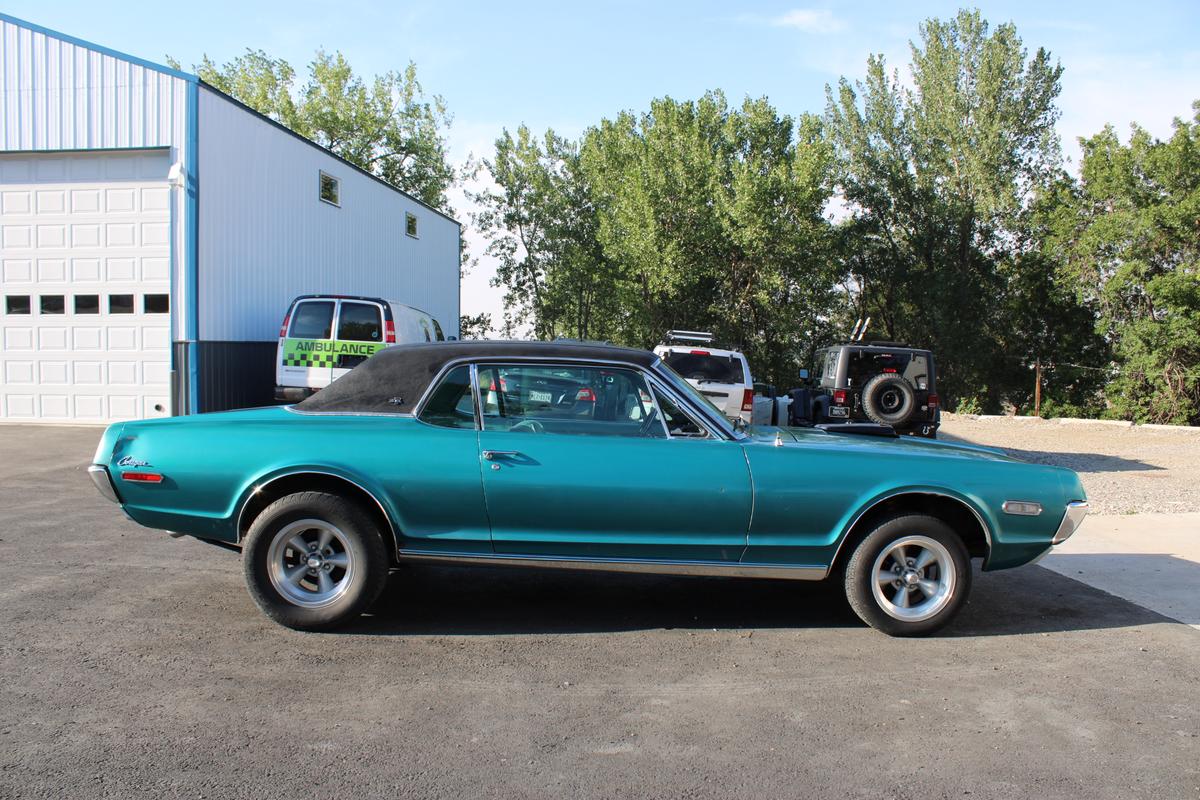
[[344, 566, 1169, 637]]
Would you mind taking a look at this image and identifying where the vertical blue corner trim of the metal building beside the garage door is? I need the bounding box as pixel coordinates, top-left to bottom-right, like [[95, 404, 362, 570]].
[[184, 82, 200, 414]]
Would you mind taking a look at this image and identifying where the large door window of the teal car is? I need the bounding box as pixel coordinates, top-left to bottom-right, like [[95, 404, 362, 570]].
[[479, 363, 666, 439]]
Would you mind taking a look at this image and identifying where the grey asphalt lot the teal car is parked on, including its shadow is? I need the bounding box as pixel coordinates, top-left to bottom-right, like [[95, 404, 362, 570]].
[[0, 426, 1200, 799]]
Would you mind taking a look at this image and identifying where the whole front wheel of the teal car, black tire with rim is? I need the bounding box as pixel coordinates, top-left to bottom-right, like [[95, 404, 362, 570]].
[[844, 515, 971, 636]]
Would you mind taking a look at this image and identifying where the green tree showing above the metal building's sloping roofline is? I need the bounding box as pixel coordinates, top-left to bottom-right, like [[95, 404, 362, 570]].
[[187, 50, 456, 210]]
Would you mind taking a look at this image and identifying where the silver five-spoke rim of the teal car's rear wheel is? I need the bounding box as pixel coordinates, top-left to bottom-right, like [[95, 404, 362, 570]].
[[266, 519, 354, 608]]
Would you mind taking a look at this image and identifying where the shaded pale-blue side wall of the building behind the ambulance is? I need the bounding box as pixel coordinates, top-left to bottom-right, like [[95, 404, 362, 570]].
[[199, 85, 458, 342]]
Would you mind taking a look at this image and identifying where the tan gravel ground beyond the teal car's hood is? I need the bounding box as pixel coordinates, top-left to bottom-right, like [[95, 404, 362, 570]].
[[938, 414, 1200, 513]]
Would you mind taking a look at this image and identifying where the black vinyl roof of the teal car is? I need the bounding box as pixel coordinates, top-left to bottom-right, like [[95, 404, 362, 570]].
[[295, 341, 659, 414]]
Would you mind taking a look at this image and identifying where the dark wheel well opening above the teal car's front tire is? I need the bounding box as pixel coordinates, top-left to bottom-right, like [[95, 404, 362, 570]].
[[830, 489, 991, 573]]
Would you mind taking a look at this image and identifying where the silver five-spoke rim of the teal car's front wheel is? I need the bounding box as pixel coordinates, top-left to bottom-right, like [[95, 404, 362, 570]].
[[871, 536, 958, 622]]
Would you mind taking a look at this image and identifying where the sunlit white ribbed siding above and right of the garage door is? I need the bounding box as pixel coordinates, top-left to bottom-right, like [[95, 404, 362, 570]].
[[0, 18, 188, 339]]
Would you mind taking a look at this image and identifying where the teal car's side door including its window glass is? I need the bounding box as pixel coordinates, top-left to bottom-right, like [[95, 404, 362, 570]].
[[478, 361, 751, 561]]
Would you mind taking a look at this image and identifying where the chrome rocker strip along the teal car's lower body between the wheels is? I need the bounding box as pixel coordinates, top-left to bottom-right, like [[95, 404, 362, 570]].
[[398, 547, 827, 581]]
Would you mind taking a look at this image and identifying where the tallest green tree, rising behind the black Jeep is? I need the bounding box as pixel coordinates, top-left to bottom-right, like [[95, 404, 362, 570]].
[[827, 11, 1067, 407]]
